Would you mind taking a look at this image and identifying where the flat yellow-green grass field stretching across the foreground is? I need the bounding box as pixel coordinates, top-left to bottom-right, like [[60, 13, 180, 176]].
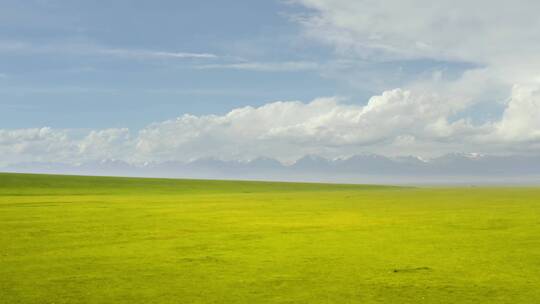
[[0, 174, 540, 304]]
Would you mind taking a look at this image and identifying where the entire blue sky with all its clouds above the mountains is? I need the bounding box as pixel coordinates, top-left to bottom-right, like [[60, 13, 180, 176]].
[[0, 0, 540, 165]]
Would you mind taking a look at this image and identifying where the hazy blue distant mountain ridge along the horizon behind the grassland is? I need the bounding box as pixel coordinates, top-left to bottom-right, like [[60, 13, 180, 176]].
[[0, 153, 540, 183]]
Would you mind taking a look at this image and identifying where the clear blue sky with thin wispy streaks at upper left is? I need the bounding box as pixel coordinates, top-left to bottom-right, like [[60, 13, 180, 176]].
[[0, 1, 340, 128]]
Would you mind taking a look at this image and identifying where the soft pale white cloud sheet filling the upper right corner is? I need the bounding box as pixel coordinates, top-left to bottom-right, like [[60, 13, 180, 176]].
[[296, 0, 540, 63]]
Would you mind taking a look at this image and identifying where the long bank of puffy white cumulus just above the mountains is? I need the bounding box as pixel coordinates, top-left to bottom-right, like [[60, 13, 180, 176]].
[[0, 87, 540, 163]]
